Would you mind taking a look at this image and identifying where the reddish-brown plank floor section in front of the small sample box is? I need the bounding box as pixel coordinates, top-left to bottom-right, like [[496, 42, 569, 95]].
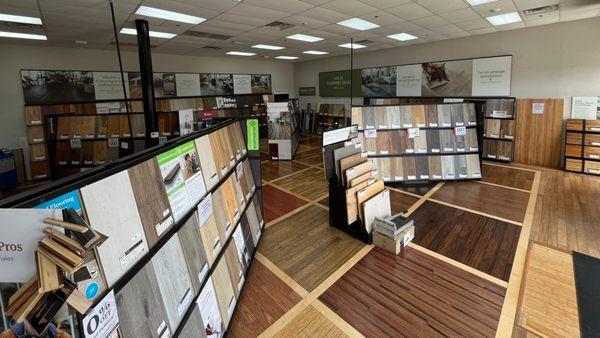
[[319, 247, 505, 337]]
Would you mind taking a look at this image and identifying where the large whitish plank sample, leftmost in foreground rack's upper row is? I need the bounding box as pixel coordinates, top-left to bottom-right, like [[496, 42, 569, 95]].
[[80, 171, 148, 287]]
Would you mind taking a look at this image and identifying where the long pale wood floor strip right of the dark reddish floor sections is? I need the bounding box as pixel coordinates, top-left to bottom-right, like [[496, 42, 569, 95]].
[[496, 171, 542, 337]]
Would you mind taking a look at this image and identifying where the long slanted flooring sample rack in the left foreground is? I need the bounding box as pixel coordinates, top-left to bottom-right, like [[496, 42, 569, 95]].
[[0, 118, 264, 337]]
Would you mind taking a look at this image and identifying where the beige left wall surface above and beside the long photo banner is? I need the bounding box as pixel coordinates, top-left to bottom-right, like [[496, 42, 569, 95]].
[[0, 44, 294, 153]]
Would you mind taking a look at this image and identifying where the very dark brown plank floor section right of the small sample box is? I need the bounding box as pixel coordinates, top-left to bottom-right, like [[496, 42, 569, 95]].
[[412, 199, 521, 281]]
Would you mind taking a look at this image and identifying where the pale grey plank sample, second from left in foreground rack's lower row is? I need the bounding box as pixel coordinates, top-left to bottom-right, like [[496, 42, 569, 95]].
[[150, 236, 196, 328]]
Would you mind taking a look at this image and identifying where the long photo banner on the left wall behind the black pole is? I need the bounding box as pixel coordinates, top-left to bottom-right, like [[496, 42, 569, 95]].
[[21, 69, 272, 105]]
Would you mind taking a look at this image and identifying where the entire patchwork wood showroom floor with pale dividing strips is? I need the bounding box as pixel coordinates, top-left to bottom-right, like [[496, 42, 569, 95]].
[[228, 136, 600, 337]]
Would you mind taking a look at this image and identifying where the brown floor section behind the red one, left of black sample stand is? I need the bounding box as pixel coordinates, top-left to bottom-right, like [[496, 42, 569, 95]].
[[272, 168, 329, 201]]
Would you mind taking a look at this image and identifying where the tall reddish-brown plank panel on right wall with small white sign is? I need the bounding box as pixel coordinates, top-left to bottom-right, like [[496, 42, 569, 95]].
[[515, 99, 564, 169]]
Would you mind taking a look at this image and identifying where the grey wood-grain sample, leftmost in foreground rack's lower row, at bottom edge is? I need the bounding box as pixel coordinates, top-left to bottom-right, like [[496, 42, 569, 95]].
[[115, 263, 175, 338]]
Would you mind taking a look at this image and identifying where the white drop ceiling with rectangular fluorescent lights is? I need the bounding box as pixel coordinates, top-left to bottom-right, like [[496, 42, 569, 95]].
[[0, 0, 600, 62]]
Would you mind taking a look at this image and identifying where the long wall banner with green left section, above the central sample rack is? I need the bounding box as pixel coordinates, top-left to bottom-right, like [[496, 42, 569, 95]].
[[319, 55, 512, 97]]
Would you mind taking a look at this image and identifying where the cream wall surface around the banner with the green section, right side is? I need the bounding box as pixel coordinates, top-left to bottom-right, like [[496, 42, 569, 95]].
[[294, 18, 600, 117]]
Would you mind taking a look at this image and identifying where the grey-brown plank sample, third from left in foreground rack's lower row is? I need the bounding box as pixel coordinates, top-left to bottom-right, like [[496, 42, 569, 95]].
[[177, 214, 212, 295]]
